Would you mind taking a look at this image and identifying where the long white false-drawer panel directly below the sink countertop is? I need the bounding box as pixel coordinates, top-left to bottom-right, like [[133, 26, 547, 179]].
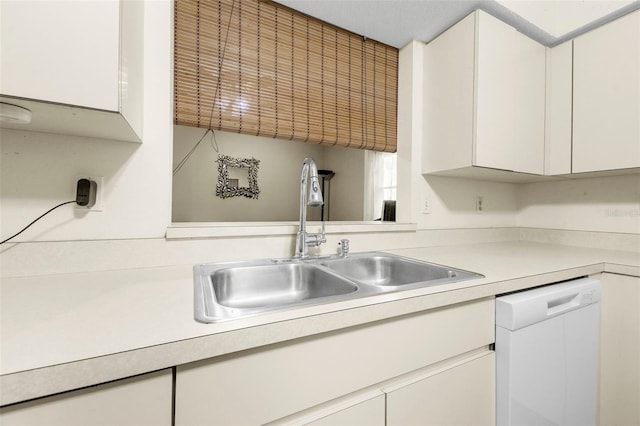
[[175, 298, 494, 426]]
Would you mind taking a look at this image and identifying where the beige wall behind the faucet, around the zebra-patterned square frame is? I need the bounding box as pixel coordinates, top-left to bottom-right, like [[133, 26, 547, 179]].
[[172, 126, 325, 222]]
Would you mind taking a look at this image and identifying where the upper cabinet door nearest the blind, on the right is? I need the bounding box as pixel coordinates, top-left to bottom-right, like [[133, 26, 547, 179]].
[[474, 12, 546, 175]]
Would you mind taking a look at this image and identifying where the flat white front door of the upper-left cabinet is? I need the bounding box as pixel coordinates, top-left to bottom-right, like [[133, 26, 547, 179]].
[[0, 0, 120, 111]]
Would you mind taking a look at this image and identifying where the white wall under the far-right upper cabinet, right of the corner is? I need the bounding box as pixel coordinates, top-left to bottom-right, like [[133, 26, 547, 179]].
[[518, 175, 640, 234]]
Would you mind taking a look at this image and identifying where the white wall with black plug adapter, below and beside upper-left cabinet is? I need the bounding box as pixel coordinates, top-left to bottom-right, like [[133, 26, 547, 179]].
[[0, 0, 173, 241]]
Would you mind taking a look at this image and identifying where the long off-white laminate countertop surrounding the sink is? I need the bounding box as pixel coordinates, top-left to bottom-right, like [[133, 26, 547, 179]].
[[0, 242, 640, 405]]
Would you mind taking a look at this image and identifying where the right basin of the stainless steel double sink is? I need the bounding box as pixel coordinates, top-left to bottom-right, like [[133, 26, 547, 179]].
[[322, 252, 482, 287]]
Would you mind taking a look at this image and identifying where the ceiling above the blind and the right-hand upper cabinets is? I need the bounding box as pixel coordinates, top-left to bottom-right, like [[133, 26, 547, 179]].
[[276, 0, 640, 48]]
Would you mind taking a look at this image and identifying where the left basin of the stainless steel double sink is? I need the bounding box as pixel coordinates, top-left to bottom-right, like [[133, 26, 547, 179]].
[[211, 263, 358, 309]]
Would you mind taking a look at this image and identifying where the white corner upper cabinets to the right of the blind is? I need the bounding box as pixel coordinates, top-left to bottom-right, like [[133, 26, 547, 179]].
[[422, 11, 640, 182]]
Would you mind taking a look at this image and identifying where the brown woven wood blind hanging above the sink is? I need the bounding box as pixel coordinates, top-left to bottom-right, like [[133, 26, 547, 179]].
[[174, 0, 398, 152]]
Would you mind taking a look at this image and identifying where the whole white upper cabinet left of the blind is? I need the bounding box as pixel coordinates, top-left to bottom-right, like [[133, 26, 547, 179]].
[[0, 0, 144, 142]]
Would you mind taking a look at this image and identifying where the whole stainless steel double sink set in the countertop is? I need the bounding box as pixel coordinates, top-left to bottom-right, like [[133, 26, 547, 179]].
[[194, 252, 483, 323]]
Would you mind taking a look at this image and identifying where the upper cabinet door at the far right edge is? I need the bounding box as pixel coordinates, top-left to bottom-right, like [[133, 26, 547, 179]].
[[572, 11, 640, 173]]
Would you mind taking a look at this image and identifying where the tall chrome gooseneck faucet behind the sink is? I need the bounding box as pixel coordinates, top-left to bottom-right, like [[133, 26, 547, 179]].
[[294, 157, 327, 258]]
